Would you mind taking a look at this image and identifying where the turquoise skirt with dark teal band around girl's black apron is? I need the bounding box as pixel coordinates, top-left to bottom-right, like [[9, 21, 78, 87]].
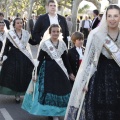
[[22, 61, 70, 116]]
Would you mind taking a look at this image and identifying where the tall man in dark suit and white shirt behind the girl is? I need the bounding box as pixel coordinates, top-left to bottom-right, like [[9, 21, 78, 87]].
[[33, 0, 69, 45]]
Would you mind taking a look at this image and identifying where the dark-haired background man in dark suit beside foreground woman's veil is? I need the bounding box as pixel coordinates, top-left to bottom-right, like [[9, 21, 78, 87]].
[[92, 10, 100, 29]]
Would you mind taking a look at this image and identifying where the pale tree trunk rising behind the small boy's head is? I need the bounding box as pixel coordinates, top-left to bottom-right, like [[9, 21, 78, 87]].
[[71, 0, 82, 32]]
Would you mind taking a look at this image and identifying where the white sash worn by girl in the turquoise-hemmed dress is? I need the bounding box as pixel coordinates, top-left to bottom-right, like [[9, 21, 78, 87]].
[[45, 40, 69, 78]]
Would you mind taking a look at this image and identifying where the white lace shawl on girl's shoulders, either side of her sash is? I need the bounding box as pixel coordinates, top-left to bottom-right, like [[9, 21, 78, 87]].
[[40, 39, 67, 59]]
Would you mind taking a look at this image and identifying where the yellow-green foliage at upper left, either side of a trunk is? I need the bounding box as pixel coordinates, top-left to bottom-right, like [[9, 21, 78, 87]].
[[0, 0, 45, 16]]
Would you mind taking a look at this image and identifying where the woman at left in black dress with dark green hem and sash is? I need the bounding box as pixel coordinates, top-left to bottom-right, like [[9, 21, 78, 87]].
[[0, 18, 34, 103]]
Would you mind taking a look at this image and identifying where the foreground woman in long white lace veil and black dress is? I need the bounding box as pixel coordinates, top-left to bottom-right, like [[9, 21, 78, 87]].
[[65, 5, 120, 120]]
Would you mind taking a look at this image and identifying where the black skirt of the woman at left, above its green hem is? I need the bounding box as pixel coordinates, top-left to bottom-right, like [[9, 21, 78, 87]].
[[0, 43, 34, 94]]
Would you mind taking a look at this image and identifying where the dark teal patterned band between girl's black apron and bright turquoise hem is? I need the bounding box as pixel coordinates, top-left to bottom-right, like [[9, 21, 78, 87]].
[[38, 61, 70, 107]]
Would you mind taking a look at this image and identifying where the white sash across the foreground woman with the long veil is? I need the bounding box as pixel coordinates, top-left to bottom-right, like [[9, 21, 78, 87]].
[[104, 36, 120, 67]]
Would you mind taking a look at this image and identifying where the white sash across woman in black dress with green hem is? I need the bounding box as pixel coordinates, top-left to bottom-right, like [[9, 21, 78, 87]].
[[8, 31, 36, 67]]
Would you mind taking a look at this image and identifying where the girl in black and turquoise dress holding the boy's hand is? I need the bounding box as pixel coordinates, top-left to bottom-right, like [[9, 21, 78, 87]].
[[22, 24, 74, 120]]
